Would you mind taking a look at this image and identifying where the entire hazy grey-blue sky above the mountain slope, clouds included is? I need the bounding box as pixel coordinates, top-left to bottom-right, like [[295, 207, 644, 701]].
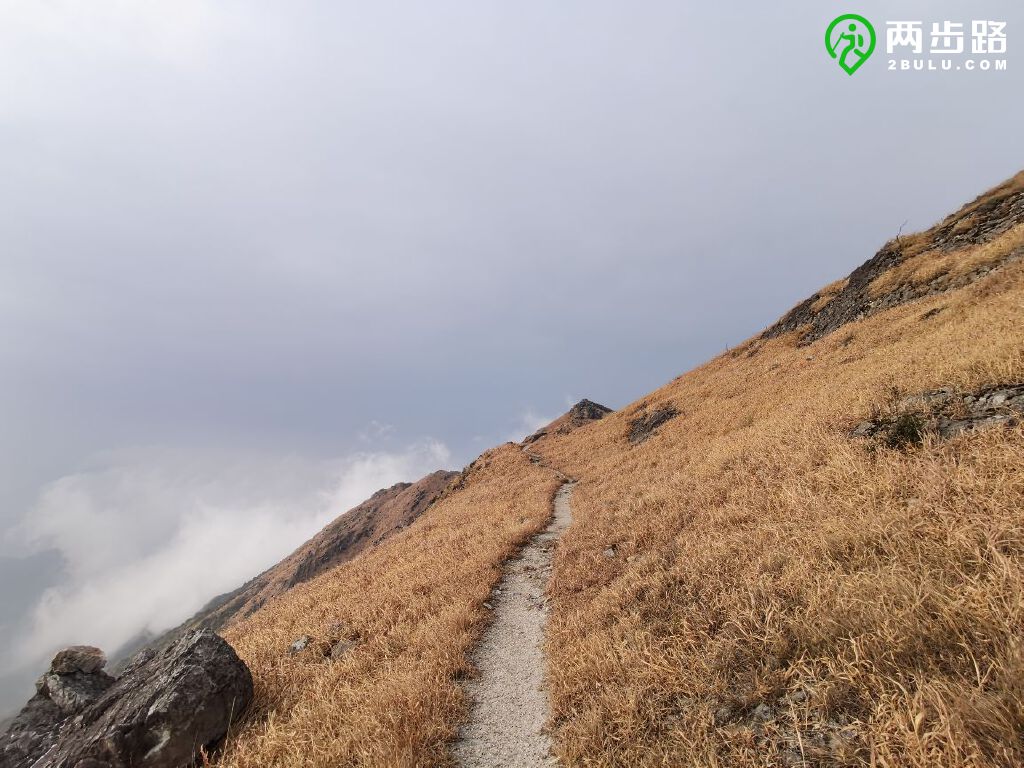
[[0, 0, 1024, 712]]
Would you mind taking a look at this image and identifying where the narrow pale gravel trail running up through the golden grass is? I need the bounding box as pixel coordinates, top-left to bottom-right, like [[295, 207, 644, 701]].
[[455, 481, 573, 768]]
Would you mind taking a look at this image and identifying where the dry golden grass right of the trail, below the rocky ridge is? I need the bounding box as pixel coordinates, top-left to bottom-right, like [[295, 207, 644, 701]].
[[534, 262, 1024, 767]]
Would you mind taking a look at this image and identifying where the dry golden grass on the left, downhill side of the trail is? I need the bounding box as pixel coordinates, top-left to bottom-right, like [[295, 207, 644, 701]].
[[210, 445, 559, 768]]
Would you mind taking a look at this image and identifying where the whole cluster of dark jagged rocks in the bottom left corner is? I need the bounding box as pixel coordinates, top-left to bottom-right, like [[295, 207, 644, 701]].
[[0, 630, 253, 768]]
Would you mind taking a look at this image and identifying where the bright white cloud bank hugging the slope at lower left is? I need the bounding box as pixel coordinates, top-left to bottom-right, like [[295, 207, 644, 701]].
[[3, 440, 451, 671]]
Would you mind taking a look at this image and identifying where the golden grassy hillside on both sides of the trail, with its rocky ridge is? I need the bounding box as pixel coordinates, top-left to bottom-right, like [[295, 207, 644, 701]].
[[211, 174, 1024, 767]]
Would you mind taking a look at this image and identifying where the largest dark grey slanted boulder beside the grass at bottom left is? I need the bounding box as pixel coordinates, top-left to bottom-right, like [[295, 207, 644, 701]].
[[32, 630, 253, 768]]
